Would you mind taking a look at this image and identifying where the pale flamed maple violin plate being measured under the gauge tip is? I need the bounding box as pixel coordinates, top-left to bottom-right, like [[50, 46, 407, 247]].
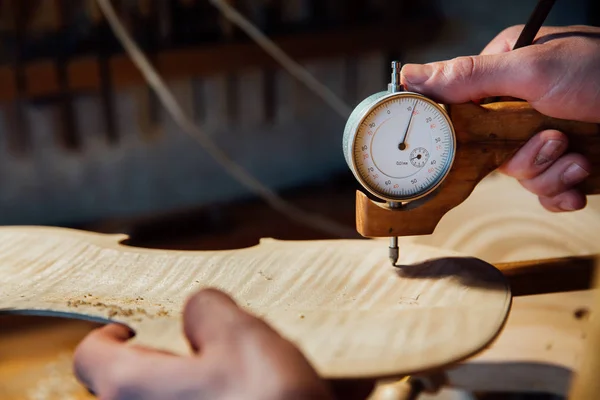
[[0, 227, 511, 378]]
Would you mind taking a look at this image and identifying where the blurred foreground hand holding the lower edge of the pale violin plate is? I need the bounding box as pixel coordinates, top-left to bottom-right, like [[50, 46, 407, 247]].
[[75, 289, 372, 400]]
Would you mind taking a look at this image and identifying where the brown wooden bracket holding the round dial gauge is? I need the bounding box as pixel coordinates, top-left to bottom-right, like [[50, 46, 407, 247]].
[[356, 101, 600, 237]]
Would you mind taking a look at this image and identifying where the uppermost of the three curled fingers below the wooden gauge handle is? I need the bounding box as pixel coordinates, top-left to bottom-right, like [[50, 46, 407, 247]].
[[498, 130, 569, 180]]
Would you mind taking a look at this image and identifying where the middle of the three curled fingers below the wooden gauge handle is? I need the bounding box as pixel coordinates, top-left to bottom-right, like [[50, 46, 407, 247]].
[[520, 153, 591, 197]]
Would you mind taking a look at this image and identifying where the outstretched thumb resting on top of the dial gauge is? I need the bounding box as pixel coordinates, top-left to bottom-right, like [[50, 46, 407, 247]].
[[400, 48, 544, 104]]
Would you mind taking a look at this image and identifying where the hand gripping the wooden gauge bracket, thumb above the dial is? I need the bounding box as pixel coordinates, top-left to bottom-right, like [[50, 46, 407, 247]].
[[401, 26, 600, 212]]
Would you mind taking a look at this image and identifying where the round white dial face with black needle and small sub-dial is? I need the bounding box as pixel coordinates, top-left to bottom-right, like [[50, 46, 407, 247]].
[[354, 95, 455, 201]]
